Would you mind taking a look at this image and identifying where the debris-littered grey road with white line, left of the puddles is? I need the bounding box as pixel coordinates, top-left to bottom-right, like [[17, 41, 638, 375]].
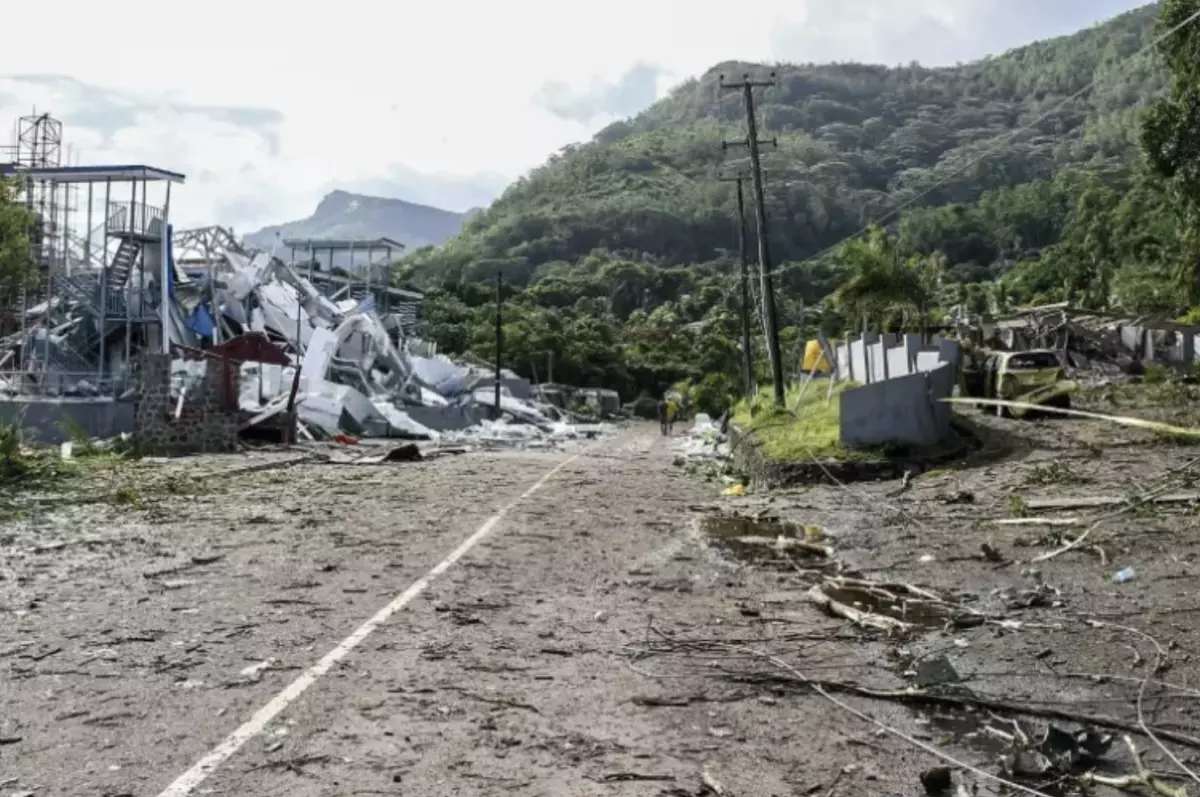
[[0, 426, 801, 797]]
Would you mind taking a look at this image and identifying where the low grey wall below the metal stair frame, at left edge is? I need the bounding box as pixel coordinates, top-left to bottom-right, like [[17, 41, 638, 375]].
[[0, 399, 133, 444]]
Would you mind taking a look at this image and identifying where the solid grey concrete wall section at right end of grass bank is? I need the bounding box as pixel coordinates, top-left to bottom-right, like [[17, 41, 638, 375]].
[[839, 362, 956, 448]]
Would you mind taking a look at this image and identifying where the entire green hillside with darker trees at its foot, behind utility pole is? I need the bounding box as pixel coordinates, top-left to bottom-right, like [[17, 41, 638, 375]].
[[397, 0, 1200, 407]]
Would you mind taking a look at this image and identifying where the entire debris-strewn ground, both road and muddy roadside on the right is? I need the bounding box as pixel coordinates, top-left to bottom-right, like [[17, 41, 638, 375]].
[[0, 398, 1200, 797]]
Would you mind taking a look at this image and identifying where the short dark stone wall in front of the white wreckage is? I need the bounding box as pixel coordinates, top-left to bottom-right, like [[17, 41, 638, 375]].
[[133, 354, 240, 456]]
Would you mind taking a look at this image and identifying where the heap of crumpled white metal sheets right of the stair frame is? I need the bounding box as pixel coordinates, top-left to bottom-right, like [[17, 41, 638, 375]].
[[179, 236, 619, 442]]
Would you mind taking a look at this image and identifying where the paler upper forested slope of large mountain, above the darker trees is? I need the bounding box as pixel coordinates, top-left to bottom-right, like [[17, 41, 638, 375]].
[[403, 6, 1166, 289]]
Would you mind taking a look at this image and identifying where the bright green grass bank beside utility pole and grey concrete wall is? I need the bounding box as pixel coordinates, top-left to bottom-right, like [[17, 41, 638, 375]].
[[733, 380, 876, 462]]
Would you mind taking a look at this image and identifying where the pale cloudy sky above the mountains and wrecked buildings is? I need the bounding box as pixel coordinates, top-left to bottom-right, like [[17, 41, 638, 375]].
[[0, 0, 1144, 233]]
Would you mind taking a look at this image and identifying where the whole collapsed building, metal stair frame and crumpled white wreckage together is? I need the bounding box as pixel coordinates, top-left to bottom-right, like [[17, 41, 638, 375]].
[[0, 114, 600, 439]]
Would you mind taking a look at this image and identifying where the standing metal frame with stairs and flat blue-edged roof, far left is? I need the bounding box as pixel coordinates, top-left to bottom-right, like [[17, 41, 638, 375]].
[[0, 113, 184, 395]]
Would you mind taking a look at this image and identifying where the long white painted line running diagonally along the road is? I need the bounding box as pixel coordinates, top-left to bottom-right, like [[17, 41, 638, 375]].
[[158, 451, 583, 797]]
